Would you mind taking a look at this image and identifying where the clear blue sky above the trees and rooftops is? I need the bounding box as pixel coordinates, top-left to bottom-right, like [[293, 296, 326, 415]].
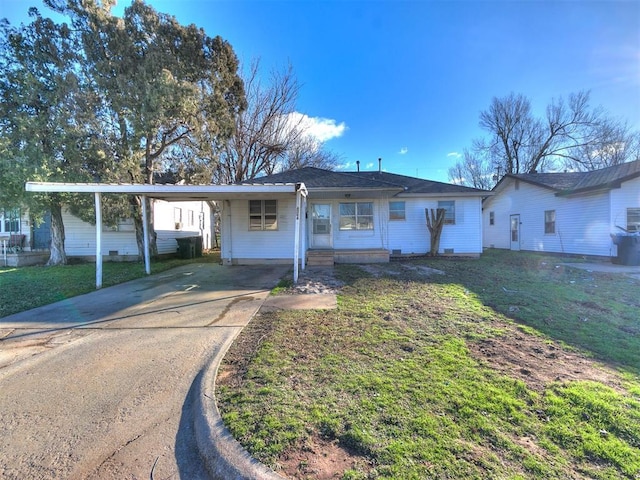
[[0, 0, 640, 181]]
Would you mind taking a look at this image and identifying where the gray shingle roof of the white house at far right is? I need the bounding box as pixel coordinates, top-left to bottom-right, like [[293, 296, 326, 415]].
[[506, 160, 640, 195]]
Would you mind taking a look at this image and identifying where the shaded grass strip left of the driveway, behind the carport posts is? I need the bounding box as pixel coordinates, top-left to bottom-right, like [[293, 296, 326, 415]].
[[0, 253, 220, 318]]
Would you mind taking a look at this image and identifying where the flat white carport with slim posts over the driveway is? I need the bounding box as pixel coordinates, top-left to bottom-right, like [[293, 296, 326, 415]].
[[25, 182, 307, 289]]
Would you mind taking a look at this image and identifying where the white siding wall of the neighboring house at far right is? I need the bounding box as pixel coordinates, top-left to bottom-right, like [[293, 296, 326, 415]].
[[483, 179, 615, 256]]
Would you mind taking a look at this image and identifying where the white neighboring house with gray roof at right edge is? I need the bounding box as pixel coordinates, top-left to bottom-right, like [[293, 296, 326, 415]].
[[483, 160, 640, 257]]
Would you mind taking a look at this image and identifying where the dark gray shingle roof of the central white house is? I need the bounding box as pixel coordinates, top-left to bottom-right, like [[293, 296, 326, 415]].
[[245, 167, 487, 194]]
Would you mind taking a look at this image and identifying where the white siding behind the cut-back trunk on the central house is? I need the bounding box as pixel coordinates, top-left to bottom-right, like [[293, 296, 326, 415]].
[[387, 197, 482, 255]]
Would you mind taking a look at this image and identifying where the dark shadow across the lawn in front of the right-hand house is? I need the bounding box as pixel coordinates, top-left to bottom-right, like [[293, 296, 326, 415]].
[[341, 251, 640, 374]]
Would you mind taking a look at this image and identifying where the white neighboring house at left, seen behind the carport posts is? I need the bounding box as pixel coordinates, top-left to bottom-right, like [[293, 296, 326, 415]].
[[0, 200, 215, 266]]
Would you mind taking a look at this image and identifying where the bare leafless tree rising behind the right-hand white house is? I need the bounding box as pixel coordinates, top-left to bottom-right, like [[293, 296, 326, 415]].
[[449, 92, 640, 188]]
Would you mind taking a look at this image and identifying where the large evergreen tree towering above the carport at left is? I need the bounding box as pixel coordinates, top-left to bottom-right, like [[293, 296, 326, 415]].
[[0, 0, 246, 263]]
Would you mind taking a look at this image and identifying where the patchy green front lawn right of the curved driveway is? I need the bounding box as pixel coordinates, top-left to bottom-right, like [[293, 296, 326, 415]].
[[218, 252, 640, 479]]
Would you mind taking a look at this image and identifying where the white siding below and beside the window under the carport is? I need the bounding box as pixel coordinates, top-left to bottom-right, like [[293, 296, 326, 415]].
[[221, 196, 296, 264]]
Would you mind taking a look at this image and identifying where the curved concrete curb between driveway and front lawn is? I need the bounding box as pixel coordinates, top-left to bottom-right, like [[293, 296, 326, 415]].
[[194, 329, 285, 480]]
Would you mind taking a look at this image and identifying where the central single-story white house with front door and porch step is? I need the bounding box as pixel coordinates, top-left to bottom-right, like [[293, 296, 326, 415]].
[[221, 167, 490, 265]]
